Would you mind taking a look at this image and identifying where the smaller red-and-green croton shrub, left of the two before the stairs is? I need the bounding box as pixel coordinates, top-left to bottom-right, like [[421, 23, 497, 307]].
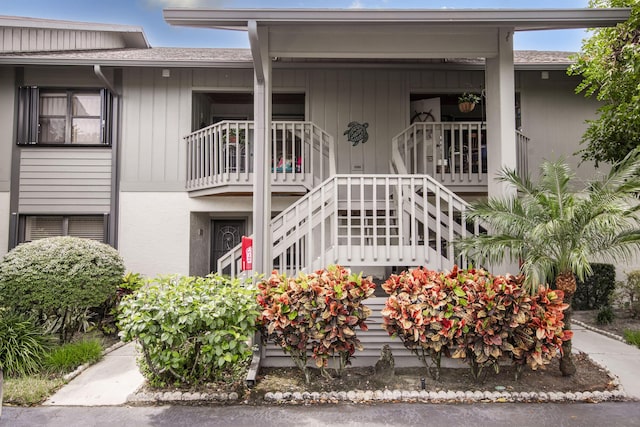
[[257, 265, 375, 382]]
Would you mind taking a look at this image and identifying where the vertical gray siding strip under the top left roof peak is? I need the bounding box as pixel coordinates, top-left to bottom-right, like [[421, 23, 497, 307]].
[[0, 27, 126, 52]]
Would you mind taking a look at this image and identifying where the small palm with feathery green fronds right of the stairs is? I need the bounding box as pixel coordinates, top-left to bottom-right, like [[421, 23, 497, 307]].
[[457, 148, 640, 375]]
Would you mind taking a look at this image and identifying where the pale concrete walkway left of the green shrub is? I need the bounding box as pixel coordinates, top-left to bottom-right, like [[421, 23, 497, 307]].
[[44, 343, 144, 406]]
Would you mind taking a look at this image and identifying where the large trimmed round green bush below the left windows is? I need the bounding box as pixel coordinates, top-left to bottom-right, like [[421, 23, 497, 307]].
[[0, 237, 124, 341]]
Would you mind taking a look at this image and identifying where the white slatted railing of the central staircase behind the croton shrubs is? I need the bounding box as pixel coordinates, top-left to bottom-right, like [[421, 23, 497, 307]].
[[218, 175, 479, 275]]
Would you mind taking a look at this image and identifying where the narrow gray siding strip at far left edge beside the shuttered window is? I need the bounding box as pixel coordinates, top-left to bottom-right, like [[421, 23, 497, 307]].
[[0, 68, 16, 191]]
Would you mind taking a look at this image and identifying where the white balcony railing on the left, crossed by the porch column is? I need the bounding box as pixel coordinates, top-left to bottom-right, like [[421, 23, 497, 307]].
[[184, 121, 336, 191]]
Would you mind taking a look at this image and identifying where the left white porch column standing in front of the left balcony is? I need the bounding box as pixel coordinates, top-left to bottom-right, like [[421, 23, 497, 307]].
[[253, 27, 273, 274]]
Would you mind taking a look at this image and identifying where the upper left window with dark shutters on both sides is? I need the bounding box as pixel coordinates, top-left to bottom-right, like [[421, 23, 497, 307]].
[[18, 87, 113, 145]]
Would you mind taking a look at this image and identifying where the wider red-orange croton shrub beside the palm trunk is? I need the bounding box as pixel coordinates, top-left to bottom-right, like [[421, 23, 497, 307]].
[[382, 266, 571, 379]]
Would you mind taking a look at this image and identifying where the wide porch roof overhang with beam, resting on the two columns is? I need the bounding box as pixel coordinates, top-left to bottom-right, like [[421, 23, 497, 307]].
[[164, 8, 630, 62]]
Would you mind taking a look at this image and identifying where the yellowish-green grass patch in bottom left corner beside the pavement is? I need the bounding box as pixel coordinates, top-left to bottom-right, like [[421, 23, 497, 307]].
[[3, 375, 64, 406]]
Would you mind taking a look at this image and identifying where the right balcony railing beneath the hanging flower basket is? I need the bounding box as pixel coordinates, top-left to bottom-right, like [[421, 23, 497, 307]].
[[393, 122, 529, 191]]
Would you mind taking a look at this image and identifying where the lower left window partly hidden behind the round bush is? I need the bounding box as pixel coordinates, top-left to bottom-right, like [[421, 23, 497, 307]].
[[21, 215, 106, 243]]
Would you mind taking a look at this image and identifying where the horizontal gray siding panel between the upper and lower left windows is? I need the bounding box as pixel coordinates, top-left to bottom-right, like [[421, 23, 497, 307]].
[[18, 147, 111, 214]]
